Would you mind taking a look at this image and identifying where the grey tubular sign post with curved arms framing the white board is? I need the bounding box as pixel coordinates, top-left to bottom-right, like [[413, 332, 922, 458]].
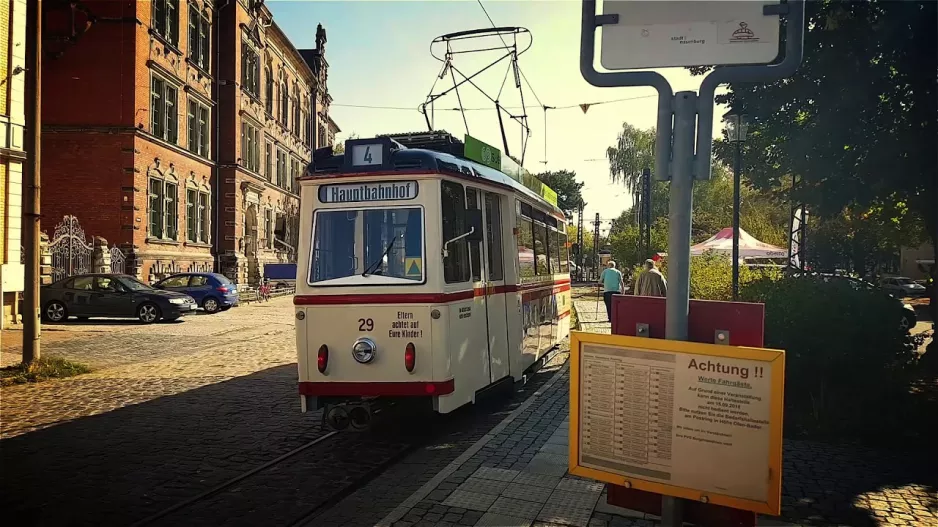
[[571, 0, 804, 527]]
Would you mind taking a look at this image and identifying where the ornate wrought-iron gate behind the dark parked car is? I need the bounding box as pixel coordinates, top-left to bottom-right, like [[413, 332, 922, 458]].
[[49, 215, 127, 282]]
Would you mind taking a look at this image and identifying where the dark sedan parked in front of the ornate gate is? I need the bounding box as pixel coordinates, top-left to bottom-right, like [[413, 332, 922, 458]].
[[40, 274, 196, 324]]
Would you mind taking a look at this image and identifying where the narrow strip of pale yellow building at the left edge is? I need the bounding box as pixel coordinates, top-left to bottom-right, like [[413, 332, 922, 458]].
[[0, 0, 27, 328]]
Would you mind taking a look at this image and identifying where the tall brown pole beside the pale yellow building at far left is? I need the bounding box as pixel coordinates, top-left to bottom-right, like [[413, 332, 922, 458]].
[[23, 0, 42, 364]]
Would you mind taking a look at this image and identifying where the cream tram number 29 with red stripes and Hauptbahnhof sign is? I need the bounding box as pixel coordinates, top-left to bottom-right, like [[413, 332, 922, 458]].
[[294, 132, 571, 429]]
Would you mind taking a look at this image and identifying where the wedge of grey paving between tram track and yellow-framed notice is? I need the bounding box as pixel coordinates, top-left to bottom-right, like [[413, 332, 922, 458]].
[[377, 358, 799, 527]]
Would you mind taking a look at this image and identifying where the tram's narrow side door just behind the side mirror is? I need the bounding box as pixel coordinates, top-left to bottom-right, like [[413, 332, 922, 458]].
[[466, 187, 509, 383]]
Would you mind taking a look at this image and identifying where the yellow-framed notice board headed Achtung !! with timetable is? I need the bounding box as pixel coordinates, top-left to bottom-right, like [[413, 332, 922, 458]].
[[570, 332, 785, 515]]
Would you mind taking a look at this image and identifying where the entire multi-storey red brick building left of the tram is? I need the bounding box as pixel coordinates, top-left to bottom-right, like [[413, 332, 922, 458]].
[[42, 0, 328, 283]]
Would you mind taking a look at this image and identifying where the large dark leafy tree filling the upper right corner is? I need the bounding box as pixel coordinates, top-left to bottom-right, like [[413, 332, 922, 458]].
[[695, 0, 938, 311]]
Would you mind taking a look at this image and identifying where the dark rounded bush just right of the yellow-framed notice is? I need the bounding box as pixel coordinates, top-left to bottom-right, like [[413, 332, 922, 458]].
[[741, 278, 912, 446]]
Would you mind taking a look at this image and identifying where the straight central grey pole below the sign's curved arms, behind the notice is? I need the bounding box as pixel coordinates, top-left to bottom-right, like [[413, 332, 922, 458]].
[[661, 91, 697, 527]]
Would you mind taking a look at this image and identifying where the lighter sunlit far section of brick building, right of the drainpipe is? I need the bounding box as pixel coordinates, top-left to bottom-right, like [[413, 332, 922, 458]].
[[218, 2, 335, 283]]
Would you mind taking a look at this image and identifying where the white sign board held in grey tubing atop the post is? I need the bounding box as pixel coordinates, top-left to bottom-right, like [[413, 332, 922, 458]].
[[600, 0, 780, 70]]
